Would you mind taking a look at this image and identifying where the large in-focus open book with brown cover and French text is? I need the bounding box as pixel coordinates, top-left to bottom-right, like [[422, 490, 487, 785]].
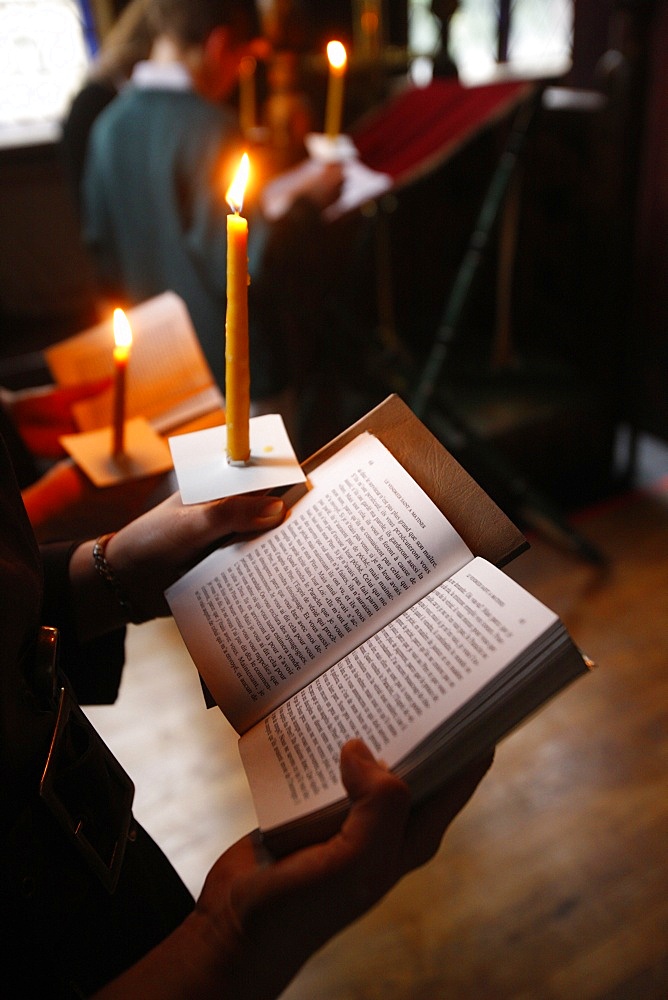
[[166, 397, 587, 853]]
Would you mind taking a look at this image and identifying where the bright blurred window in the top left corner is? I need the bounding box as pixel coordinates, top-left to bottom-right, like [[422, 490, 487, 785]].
[[0, 0, 92, 144]]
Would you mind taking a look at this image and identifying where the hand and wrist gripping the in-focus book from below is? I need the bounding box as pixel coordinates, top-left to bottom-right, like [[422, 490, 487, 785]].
[[193, 740, 490, 1000]]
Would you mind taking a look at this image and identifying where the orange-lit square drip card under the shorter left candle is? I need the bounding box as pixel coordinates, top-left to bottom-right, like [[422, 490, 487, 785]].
[[60, 417, 172, 487]]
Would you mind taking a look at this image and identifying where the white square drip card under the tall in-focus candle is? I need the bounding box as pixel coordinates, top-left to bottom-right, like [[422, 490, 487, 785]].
[[169, 414, 306, 504]]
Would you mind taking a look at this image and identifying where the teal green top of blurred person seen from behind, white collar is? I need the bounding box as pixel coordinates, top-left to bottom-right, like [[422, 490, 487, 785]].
[[82, 84, 283, 399]]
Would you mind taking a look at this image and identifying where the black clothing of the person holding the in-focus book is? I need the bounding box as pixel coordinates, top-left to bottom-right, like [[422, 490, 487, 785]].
[[0, 438, 194, 1000]]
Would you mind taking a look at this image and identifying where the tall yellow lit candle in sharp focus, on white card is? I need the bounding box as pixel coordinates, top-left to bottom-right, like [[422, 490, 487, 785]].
[[225, 153, 250, 465]]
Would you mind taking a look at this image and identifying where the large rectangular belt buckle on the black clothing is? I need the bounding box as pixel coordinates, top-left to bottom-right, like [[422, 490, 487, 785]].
[[40, 687, 134, 892]]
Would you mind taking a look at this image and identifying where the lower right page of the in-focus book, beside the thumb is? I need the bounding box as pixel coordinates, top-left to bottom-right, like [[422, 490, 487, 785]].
[[239, 558, 558, 830]]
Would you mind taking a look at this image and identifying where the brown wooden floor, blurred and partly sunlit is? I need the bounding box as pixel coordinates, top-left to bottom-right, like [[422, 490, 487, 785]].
[[85, 472, 668, 1000]]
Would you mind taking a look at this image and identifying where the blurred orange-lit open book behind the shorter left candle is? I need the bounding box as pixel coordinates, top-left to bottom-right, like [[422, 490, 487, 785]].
[[45, 292, 224, 434]]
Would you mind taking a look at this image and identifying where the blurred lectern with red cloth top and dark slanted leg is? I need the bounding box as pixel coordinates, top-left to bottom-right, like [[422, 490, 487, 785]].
[[353, 80, 605, 565]]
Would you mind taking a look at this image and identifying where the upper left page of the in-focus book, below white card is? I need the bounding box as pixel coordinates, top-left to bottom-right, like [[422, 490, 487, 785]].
[[166, 433, 471, 732]]
